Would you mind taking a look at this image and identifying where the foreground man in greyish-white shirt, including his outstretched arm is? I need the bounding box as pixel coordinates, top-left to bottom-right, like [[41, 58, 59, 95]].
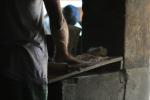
[[0, 0, 80, 100]]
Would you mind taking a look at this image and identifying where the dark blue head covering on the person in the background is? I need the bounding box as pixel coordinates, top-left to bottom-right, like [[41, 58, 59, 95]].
[[63, 5, 80, 25]]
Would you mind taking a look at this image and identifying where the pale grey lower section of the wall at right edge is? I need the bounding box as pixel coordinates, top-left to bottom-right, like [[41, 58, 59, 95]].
[[125, 67, 149, 100]]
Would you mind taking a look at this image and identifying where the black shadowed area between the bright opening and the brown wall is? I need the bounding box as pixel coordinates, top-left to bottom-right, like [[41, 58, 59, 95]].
[[82, 0, 125, 56]]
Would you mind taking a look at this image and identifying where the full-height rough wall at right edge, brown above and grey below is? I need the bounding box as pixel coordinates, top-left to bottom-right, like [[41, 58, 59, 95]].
[[124, 0, 150, 100]]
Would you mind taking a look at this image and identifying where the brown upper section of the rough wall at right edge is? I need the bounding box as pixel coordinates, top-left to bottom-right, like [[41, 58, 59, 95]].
[[125, 0, 150, 68]]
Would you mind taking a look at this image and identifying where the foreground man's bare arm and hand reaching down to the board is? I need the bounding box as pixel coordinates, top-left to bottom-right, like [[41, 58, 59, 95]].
[[44, 0, 80, 64]]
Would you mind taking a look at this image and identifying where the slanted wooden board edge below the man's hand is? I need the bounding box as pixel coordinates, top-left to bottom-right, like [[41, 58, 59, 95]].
[[48, 57, 123, 84]]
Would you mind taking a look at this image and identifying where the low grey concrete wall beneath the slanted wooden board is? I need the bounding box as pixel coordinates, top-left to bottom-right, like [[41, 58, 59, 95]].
[[62, 72, 124, 100]]
